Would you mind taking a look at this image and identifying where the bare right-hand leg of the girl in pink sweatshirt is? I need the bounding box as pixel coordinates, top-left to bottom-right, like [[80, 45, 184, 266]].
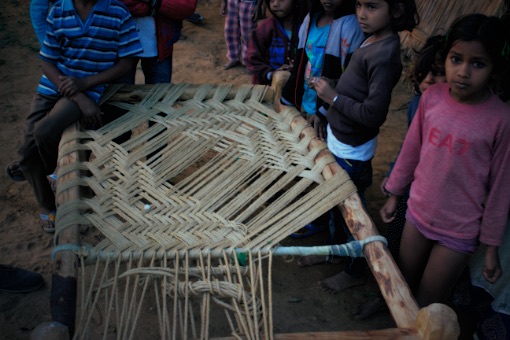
[[416, 242, 470, 307]]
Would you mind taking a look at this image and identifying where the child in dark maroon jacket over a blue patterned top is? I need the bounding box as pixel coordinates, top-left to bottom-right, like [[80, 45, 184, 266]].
[[246, 0, 306, 85]]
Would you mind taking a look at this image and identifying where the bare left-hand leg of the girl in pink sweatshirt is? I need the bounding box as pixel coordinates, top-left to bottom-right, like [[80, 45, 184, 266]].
[[399, 221, 434, 292]]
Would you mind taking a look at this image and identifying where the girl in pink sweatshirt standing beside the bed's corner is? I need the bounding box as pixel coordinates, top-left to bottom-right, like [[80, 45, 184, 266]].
[[381, 14, 510, 306]]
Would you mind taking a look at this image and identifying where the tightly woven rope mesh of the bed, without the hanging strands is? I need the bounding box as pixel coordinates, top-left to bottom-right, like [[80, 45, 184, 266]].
[[57, 84, 355, 259]]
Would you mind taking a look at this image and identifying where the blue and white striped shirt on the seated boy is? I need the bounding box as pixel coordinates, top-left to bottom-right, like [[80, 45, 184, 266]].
[[37, 0, 142, 102]]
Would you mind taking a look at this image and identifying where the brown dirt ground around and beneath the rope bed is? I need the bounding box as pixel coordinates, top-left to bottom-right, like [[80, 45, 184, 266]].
[[0, 0, 412, 339]]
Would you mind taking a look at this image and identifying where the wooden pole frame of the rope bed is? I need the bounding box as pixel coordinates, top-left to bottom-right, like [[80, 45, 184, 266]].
[[41, 80, 460, 340]]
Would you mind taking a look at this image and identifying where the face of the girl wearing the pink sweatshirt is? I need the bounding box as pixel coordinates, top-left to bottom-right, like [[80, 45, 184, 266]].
[[445, 41, 494, 104]]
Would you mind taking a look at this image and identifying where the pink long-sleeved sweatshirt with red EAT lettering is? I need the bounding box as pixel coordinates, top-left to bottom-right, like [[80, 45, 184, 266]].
[[386, 84, 510, 246]]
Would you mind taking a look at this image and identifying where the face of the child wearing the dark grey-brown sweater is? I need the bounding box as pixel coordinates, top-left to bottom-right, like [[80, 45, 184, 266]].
[[356, 0, 392, 34]]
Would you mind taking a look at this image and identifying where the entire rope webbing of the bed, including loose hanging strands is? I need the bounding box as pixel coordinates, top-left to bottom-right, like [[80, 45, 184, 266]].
[[56, 84, 356, 339]]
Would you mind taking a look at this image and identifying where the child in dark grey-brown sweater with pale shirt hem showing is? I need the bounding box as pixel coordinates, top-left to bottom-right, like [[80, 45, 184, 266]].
[[313, 0, 419, 293]]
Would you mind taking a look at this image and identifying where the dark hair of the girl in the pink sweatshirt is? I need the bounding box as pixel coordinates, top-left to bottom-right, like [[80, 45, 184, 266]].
[[444, 14, 510, 96]]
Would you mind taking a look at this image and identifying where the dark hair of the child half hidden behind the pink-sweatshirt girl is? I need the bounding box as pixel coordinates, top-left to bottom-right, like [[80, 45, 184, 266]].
[[411, 35, 445, 93]]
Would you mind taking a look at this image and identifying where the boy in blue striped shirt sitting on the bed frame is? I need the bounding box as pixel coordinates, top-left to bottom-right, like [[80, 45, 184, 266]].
[[7, 0, 142, 232]]
